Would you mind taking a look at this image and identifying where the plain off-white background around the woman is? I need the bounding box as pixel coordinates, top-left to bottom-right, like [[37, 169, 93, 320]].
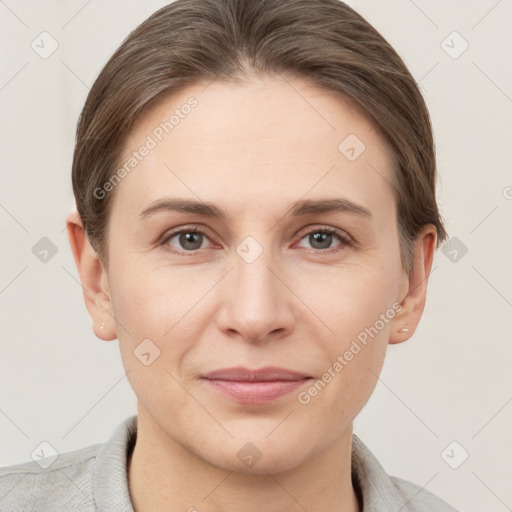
[[0, 0, 512, 512]]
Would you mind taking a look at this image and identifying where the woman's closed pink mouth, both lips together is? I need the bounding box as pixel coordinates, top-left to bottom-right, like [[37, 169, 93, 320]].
[[201, 367, 312, 405]]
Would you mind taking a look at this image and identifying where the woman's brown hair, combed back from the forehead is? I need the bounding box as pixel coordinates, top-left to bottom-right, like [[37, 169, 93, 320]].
[[72, 0, 447, 273]]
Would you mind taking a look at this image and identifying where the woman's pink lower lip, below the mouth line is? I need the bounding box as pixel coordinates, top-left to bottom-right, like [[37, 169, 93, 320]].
[[206, 379, 310, 404]]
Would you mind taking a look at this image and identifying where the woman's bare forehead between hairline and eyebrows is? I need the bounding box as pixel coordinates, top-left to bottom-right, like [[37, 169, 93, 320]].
[[109, 77, 392, 220]]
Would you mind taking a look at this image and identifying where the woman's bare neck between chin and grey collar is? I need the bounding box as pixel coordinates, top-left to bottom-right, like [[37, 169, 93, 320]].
[[128, 408, 362, 512]]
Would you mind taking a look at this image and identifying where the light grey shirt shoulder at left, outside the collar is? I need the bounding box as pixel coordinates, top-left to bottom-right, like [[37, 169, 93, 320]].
[[0, 444, 101, 512]]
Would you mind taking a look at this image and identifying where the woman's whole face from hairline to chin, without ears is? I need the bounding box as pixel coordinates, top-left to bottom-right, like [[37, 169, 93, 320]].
[[103, 74, 407, 472]]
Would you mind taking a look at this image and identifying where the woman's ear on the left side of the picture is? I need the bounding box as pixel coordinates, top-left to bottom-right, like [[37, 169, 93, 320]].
[[66, 210, 117, 341]]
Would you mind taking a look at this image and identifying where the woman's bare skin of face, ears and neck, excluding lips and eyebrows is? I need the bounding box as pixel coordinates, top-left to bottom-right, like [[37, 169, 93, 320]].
[[67, 76, 436, 512]]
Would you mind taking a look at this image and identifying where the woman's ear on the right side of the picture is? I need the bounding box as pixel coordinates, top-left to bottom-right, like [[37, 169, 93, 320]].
[[388, 224, 437, 344]]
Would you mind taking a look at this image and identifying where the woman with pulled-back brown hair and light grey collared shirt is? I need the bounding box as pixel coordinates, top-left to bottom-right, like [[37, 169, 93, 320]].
[[0, 0, 455, 512]]
